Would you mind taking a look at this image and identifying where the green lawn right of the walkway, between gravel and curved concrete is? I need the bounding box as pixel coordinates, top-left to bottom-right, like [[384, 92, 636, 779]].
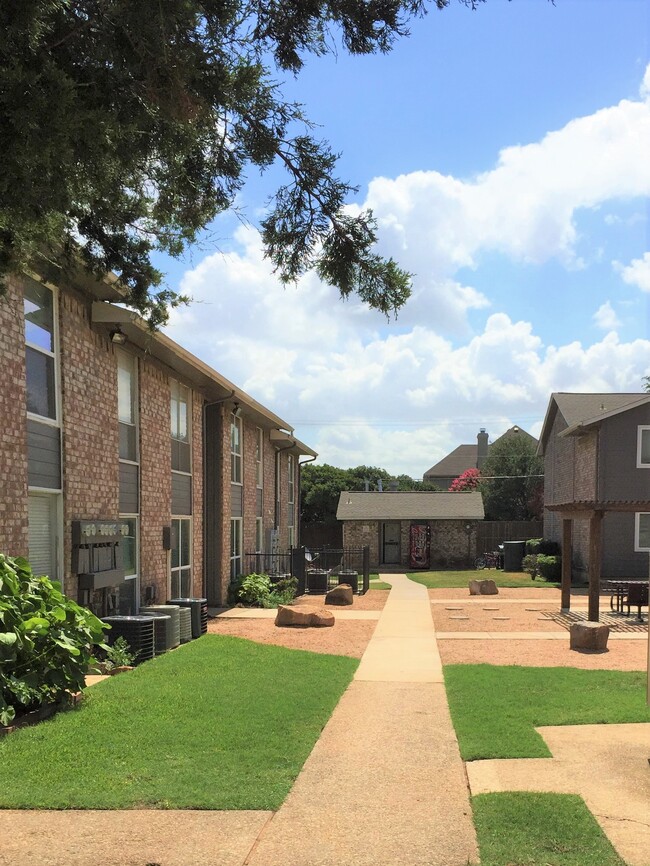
[[444, 665, 650, 761]]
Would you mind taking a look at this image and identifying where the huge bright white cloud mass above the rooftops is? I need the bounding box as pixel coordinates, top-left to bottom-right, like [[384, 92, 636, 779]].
[[163, 64, 650, 476]]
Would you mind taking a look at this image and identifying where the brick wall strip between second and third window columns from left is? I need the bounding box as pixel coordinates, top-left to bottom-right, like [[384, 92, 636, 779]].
[[139, 359, 172, 604]]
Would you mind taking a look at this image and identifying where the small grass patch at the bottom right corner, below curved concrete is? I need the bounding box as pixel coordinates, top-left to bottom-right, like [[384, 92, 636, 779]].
[[472, 793, 625, 866]]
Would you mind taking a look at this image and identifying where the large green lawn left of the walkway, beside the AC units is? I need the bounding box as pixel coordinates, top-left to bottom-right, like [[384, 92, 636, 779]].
[[0, 635, 358, 809]]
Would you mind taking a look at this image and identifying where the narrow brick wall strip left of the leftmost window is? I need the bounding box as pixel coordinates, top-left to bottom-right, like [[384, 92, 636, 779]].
[[0, 277, 28, 556]]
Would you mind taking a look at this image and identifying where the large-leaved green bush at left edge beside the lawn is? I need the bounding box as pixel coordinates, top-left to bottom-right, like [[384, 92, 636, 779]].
[[0, 554, 107, 725]]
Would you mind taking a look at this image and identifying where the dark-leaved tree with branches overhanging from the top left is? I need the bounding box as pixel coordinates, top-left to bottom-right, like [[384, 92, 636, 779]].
[[0, 0, 484, 325]]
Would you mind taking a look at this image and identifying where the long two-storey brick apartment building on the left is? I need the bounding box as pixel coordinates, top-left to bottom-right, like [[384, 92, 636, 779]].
[[0, 266, 316, 613]]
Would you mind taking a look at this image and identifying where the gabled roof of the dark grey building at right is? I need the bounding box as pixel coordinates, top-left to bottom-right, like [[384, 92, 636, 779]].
[[537, 392, 650, 454]]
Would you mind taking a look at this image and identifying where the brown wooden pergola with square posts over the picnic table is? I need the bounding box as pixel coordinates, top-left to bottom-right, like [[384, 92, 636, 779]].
[[546, 499, 650, 622]]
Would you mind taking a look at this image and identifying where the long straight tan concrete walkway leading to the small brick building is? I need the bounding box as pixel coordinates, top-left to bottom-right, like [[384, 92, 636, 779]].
[[247, 575, 478, 866]]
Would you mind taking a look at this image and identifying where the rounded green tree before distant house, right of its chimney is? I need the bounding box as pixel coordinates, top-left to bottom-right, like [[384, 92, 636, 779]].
[[479, 434, 544, 520]]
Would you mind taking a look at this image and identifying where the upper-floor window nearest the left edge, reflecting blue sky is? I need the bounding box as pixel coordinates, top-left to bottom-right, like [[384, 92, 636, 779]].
[[23, 279, 57, 421]]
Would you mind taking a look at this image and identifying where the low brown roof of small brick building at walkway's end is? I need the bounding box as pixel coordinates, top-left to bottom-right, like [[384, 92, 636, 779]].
[[336, 490, 485, 520]]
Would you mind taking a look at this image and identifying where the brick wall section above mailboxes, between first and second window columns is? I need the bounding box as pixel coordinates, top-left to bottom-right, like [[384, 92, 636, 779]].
[[60, 292, 119, 597]]
